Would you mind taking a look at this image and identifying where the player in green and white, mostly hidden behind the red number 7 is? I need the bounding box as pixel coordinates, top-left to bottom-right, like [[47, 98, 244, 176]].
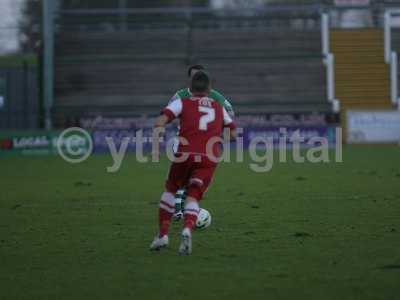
[[170, 65, 235, 220]]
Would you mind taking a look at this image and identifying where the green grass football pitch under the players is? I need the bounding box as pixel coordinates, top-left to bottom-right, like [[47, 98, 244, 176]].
[[0, 146, 400, 300]]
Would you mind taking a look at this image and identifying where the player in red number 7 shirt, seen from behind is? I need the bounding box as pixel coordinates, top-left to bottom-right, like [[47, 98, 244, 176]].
[[150, 71, 236, 255]]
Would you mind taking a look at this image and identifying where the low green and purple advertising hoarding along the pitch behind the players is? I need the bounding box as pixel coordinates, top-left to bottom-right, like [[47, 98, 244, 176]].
[[0, 114, 340, 156]]
